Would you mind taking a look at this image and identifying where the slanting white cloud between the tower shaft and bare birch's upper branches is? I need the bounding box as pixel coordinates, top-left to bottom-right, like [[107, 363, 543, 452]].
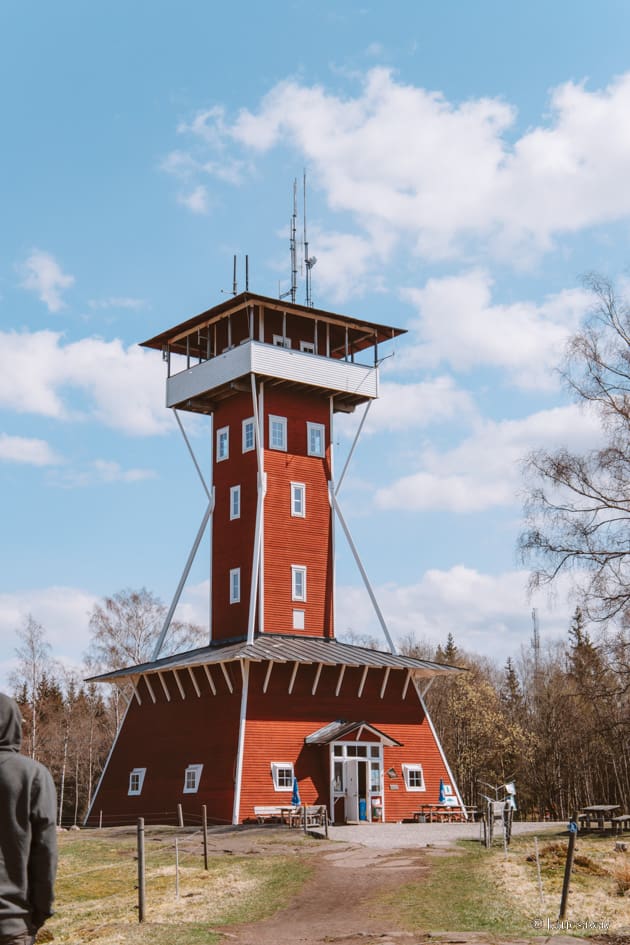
[[374, 405, 602, 513]]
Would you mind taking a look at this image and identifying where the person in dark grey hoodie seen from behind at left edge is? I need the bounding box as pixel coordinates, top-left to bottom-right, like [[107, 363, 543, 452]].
[[0, 693, 57, 945]]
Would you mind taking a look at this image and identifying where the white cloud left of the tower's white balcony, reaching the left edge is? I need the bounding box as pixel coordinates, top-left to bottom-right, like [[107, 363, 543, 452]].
[[0, 331, 173, 435]]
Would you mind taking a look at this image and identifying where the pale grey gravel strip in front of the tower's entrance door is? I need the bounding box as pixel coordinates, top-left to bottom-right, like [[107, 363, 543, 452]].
[[328, 821, 567, 850]]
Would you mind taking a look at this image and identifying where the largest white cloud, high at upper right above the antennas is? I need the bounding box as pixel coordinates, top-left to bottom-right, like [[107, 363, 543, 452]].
[[178, 68, 630, 264]]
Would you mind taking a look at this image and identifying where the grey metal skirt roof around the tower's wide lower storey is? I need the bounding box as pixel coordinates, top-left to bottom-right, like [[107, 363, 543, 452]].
[[88, 633, 464, 682]]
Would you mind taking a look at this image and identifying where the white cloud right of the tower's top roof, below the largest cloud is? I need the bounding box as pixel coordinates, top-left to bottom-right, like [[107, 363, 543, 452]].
[[401, 270, 592, 390]]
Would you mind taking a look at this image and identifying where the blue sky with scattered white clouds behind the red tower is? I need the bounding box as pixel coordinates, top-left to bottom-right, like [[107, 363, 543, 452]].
[[0, 0, 630, 678]]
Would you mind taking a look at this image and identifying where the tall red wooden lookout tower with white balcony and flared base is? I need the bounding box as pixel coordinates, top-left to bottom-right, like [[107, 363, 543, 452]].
[[88, 292, 459, 823]]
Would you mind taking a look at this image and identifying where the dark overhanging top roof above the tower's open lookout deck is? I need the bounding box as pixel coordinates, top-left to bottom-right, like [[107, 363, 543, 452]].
[[141, 292, 406, 357]]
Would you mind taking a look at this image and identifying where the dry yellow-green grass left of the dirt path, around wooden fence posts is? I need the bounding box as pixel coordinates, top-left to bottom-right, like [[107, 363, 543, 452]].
[[46, 828, 311, 945]]
